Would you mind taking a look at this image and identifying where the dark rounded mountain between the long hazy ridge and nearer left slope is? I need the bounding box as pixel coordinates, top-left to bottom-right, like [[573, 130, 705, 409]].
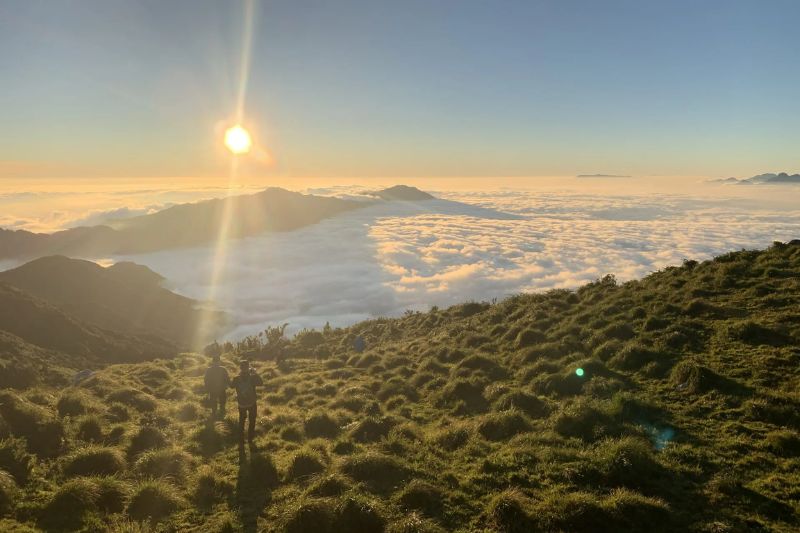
[[0, 256, 224, 347]]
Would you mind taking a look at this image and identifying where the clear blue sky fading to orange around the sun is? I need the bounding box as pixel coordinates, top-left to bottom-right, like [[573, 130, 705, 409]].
[[0, 0, 800, 181]]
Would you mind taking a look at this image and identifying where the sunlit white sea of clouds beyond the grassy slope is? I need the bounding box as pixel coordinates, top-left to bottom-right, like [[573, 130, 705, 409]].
[[1, 177, 800, 339]]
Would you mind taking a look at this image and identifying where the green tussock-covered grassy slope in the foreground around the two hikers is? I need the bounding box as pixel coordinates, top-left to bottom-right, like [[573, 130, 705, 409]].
[[0, 245, 800, 533]]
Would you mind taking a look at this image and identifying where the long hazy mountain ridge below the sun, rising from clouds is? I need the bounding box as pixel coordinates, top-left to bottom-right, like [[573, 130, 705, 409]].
[[0, 188, 365, 259]]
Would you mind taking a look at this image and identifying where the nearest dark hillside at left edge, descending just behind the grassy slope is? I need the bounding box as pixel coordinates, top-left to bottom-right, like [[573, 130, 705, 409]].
[[0, 282, 176, 366]]
